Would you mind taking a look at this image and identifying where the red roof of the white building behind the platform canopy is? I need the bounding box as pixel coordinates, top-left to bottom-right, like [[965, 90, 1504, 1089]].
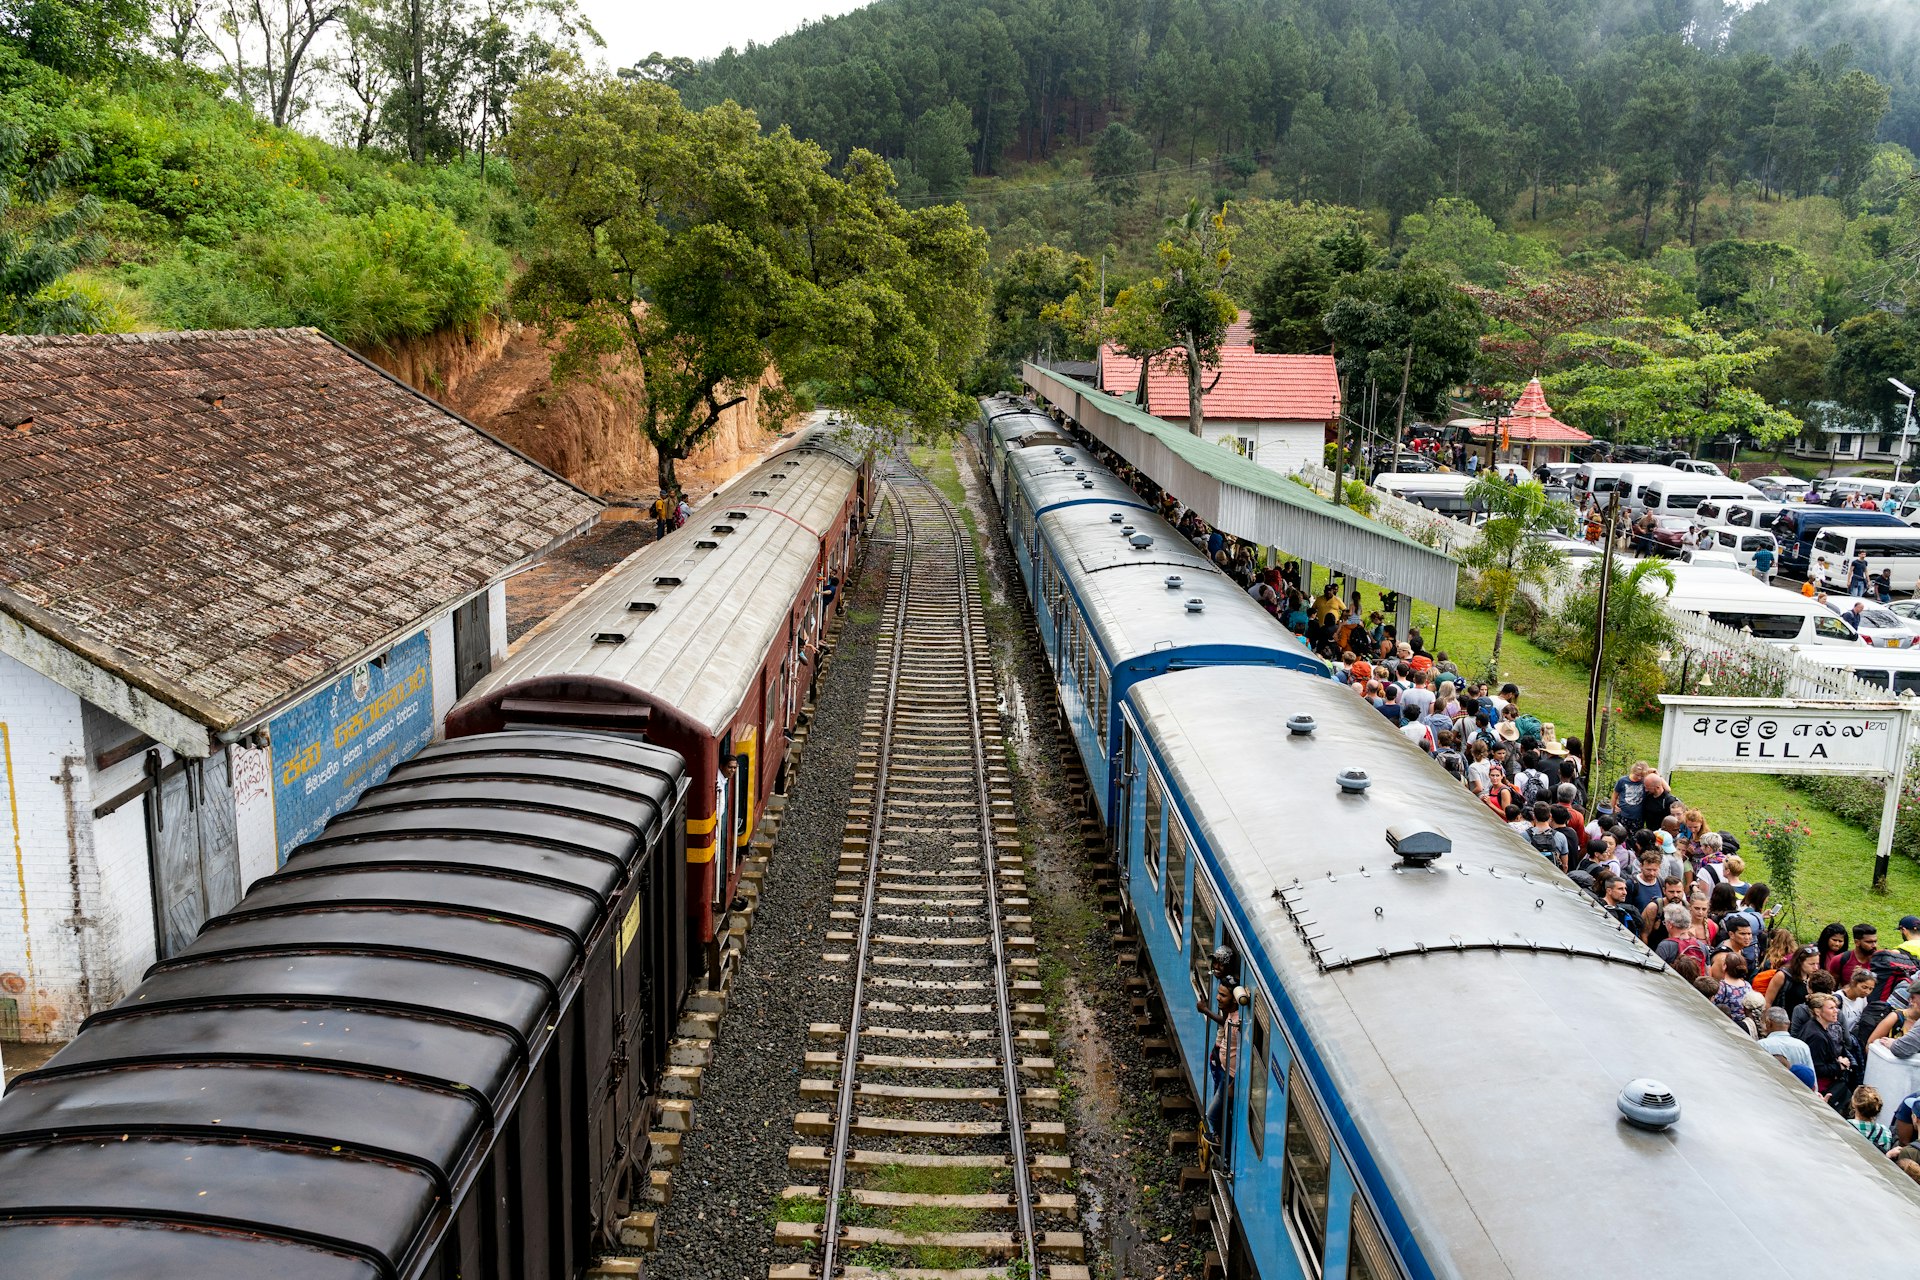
[[1100, 347, 1340, 422]]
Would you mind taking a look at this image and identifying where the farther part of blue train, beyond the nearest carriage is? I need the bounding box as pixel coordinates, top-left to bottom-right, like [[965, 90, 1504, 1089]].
[[981, 397, 1329, 823]]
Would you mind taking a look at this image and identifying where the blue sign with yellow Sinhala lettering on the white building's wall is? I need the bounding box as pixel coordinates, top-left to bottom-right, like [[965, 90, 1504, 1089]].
[[267, 631, 434, 864]]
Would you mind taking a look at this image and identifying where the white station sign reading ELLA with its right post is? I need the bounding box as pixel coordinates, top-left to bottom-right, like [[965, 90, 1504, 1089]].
[[1661, 695, 1920, 889]]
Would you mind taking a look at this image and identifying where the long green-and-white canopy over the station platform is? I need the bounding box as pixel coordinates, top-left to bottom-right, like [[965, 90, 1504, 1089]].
[[1025, 361, 1459, 608]]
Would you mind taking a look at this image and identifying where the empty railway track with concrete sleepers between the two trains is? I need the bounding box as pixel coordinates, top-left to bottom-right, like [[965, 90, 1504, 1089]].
[[770, 461, 1089, 1280]]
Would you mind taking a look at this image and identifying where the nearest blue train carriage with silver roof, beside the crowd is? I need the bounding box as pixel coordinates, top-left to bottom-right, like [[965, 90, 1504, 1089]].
[[989, 395, 1920, 1280]]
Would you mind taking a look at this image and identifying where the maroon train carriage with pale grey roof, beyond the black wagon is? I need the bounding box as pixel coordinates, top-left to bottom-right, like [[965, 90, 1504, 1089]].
[[447, 428, 870, 975]]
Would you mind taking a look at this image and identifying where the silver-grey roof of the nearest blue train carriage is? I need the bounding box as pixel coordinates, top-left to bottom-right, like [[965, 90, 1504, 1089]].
[[1129, 668, 1920, 1280]]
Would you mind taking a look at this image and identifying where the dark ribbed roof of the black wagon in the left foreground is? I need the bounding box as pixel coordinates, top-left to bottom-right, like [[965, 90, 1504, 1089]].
[[0, 731, 684, 1280]]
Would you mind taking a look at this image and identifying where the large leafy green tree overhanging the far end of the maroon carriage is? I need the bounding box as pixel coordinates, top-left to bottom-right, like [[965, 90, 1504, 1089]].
[[507, 61, 987, 487]]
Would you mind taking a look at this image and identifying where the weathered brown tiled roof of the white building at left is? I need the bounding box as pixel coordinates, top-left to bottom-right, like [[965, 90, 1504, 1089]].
[[0, 328, 599, 731]]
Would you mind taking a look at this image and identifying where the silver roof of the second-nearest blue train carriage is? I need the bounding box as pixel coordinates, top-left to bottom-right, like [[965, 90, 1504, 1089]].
[[1039, 491, 1325, 672]]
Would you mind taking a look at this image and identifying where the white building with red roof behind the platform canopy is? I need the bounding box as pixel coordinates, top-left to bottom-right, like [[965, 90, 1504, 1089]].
[[1098, 345, 1340, 472]]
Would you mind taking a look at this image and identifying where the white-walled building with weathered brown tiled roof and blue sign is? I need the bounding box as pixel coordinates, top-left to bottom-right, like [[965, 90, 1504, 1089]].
[[0, 330, 599, 1040]]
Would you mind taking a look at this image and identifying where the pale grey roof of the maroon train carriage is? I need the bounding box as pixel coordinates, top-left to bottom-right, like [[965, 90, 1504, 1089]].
[[463, 428, 860, 733]]
